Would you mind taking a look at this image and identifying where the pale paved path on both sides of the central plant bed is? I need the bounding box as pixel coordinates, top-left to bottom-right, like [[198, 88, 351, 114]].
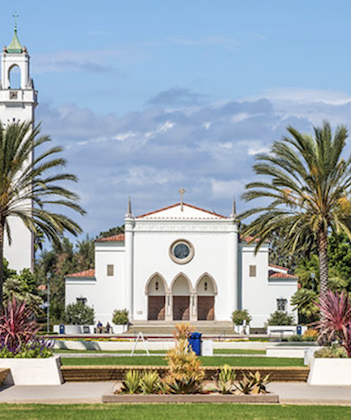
[[0, 382, 351, 406]]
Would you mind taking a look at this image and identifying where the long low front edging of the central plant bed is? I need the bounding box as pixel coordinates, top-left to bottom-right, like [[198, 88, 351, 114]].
[[102, 394, 279, 404]]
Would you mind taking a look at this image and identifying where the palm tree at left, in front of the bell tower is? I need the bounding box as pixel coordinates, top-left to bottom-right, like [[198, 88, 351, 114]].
[[0, 122, 85, 310]]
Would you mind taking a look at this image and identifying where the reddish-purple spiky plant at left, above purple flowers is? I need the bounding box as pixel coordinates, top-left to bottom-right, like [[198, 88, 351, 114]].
[[0, 297, 39, 352]]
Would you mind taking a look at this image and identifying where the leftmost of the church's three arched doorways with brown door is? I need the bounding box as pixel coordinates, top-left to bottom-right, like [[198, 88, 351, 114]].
[[145, 273, 167, 321]]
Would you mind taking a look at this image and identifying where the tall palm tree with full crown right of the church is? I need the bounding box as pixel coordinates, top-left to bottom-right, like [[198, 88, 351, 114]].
[[240, 122, 351, 295]]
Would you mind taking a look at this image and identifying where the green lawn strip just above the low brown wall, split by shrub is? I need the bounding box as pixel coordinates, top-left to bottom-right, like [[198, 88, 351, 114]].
[[62, 356, 304, 366]]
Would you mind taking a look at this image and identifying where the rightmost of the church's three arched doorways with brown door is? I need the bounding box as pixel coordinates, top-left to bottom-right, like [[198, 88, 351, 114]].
[[196, 273, 217, 321]]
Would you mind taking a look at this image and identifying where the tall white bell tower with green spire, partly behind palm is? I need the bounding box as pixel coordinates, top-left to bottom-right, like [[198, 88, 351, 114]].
[[0, 15, 38, 272]]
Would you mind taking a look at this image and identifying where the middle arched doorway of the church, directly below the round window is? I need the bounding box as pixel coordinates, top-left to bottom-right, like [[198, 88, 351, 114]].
[[171, 274, 191, 321]]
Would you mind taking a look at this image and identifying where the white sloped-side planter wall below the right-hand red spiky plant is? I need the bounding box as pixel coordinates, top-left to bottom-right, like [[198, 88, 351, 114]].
[[307, 358, 351, 386]]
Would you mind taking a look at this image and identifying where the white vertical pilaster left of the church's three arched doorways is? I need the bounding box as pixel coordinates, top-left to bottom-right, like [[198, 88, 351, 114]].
[[124, 213, 134, 320]]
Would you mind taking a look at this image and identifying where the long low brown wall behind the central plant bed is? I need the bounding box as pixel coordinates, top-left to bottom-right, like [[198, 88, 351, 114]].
[[61, 366, 310, 382]]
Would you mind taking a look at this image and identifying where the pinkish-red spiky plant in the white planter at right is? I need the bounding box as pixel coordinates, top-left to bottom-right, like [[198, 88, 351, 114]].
[[317, 290, 351, 343]]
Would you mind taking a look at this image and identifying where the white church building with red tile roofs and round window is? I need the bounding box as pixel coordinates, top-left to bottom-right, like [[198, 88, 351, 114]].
[[66, 202, 297, 327]]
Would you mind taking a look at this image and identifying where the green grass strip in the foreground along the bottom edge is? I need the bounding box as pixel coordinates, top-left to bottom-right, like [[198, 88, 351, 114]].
[[0, 404, 351, 420]]
